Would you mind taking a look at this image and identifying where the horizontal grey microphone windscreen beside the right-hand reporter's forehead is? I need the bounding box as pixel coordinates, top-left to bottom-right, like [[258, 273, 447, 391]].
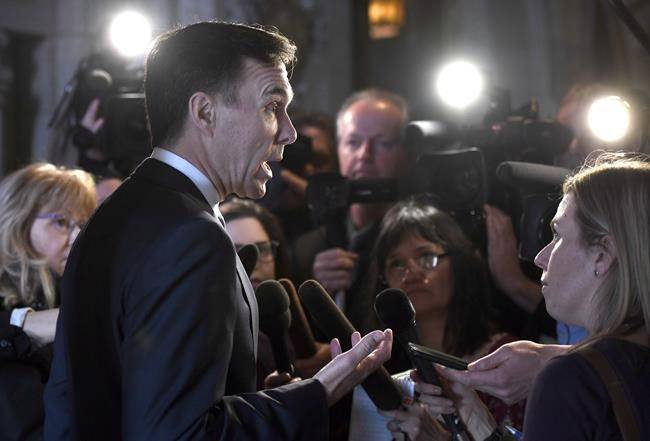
[[497, 161, 571, 187]]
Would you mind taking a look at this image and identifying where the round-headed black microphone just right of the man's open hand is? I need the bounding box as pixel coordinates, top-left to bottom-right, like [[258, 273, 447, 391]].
[[375, 288, 468, 440]]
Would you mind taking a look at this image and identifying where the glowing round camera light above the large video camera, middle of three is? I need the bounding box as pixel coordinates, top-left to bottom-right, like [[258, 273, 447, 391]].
[[436, 61, 483, 109]]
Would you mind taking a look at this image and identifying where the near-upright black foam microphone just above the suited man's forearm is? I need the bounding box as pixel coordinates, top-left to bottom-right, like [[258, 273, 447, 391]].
[[255, 280, 293, 376]]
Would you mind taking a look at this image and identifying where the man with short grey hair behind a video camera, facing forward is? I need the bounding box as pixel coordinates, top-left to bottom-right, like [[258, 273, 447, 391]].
[[294, 89, 410, 326]]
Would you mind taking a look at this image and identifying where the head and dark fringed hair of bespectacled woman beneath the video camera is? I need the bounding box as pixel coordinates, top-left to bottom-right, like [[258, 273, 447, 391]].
[[364, 199, 492, 360]]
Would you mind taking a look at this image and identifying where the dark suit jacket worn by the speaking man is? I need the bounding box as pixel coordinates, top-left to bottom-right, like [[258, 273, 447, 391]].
[[45, 159, 327, 440]]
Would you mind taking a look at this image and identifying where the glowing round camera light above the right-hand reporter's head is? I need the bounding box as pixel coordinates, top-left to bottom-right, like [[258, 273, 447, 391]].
[[587, 96, 630, 142]]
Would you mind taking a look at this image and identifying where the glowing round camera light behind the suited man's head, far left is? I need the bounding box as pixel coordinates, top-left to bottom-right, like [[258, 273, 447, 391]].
[[109, 11, 151, 57]]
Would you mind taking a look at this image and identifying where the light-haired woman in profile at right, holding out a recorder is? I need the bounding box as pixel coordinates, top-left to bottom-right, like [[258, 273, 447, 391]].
[[418, 153, 650, 441]]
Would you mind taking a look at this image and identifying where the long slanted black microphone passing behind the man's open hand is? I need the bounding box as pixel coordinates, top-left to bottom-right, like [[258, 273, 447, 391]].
[[298, 280, 402, 410]]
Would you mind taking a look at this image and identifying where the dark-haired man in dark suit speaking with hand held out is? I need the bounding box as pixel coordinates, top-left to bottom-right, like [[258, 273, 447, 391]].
[[45, 22, 392, 440]]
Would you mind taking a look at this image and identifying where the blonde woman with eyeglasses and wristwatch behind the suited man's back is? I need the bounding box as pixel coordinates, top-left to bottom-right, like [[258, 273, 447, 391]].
[[0, 163, 96, 439]]
